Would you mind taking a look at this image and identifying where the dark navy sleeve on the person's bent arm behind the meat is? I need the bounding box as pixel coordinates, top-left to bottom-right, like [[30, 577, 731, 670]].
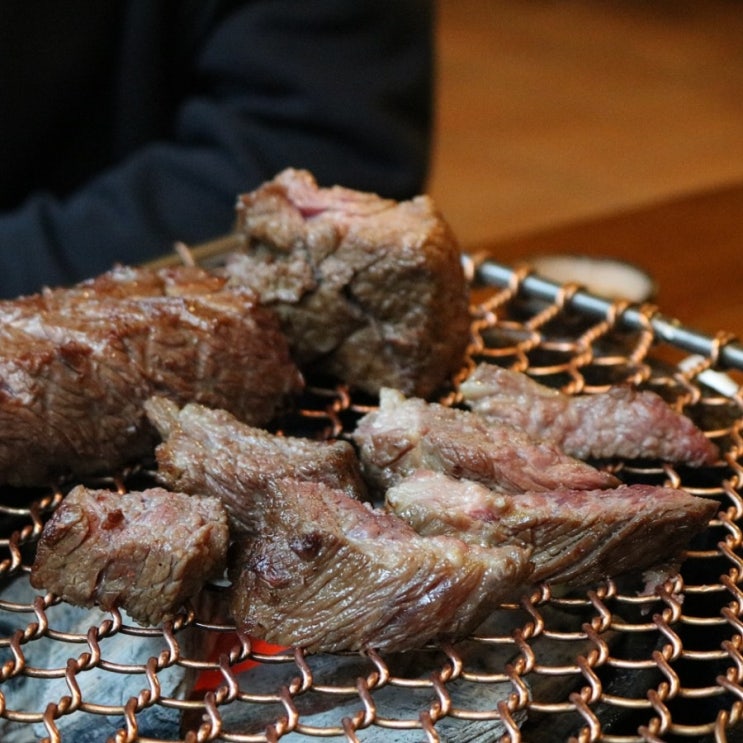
[[0, 0, 433, 297]]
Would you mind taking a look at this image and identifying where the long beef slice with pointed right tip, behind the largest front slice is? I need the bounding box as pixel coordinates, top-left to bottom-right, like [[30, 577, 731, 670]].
[[385, 470, 719, 586]]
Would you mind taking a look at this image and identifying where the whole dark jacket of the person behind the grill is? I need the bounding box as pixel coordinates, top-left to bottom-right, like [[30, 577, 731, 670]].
[[0, 0, 433, 297]]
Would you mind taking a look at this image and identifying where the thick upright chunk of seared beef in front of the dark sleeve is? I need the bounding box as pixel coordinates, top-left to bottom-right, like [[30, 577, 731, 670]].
[[225, 169, 471, 397]]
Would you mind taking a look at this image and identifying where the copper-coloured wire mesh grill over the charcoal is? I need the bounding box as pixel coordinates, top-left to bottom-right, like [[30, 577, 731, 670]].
[[0, 258, 743, 743]]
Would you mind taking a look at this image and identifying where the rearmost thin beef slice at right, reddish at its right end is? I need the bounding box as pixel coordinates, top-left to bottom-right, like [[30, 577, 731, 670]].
[[459, 363, 719, 466]]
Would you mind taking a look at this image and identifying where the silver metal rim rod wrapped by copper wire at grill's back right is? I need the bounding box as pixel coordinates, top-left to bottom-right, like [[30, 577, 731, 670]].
[[474, 258, 743, 370]]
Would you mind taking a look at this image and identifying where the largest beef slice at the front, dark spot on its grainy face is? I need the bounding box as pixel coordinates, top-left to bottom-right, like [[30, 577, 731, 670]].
[[231, 479, 531, 652]]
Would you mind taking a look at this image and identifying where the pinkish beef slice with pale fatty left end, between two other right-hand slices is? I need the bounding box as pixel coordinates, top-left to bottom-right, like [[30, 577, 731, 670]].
[[352, 389, 618, 494]]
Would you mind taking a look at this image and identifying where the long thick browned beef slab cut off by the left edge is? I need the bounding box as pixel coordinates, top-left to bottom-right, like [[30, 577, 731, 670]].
[[0, 268, 303, 485]]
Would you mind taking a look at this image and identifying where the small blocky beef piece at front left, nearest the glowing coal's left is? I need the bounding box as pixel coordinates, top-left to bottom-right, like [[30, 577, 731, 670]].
[[31, 485, 229, 625]]
